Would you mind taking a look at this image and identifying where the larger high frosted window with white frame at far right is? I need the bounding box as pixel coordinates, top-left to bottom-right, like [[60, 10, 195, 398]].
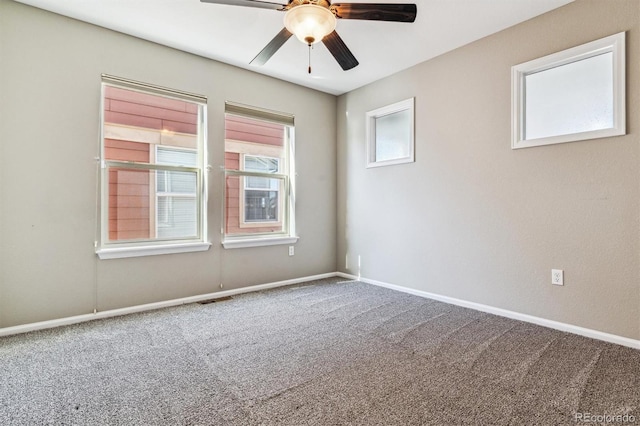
[[511, 33, 626, 149]]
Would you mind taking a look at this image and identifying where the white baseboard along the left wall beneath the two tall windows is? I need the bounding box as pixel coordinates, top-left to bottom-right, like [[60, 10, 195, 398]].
[[0, 272, 337, 337]]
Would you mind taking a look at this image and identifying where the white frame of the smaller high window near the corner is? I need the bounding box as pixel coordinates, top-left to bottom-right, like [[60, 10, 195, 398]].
[[366, 98, 415, 168]]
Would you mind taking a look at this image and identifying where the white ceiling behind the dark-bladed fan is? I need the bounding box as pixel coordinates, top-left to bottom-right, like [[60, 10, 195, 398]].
[[12, 0, 573, 95]]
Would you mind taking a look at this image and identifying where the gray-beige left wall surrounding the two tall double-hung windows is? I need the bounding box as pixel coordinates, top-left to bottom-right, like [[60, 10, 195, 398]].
[[0, 0, 336, 327]]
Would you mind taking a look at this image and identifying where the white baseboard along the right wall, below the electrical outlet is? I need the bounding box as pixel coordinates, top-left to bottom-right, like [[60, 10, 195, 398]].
[[336, 272, 640, 349]]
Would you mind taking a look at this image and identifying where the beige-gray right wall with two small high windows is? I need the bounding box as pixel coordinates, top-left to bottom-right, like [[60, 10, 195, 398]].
[[338, 0, 640, 339]]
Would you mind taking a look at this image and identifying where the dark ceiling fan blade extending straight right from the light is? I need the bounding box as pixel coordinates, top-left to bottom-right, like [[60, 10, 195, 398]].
[[331, 3, 418, 22]]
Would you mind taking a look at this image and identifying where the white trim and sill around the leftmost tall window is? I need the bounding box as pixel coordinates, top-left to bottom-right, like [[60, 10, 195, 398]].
[[94, 74, 211, 260]]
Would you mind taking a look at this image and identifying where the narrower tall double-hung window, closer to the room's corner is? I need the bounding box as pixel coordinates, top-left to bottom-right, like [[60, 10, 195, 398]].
[[223, 102, 297, 248]]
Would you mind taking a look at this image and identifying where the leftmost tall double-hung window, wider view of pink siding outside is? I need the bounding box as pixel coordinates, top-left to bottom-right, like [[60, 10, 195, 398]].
[[97, 76, 210, 259]]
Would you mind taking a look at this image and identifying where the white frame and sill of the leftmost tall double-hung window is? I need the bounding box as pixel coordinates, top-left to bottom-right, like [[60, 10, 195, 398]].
[[95, 74, 211, 259]]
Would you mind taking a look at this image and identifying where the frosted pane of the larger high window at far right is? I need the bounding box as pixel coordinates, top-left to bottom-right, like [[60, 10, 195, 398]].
[[524, 52, 613, 139]]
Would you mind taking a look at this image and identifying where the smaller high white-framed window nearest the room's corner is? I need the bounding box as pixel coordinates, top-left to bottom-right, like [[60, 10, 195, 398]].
[[367, 98, 415, 167]]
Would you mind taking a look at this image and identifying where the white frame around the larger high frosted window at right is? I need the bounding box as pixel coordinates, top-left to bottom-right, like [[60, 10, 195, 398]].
[[511, 32, 626, 149]]
